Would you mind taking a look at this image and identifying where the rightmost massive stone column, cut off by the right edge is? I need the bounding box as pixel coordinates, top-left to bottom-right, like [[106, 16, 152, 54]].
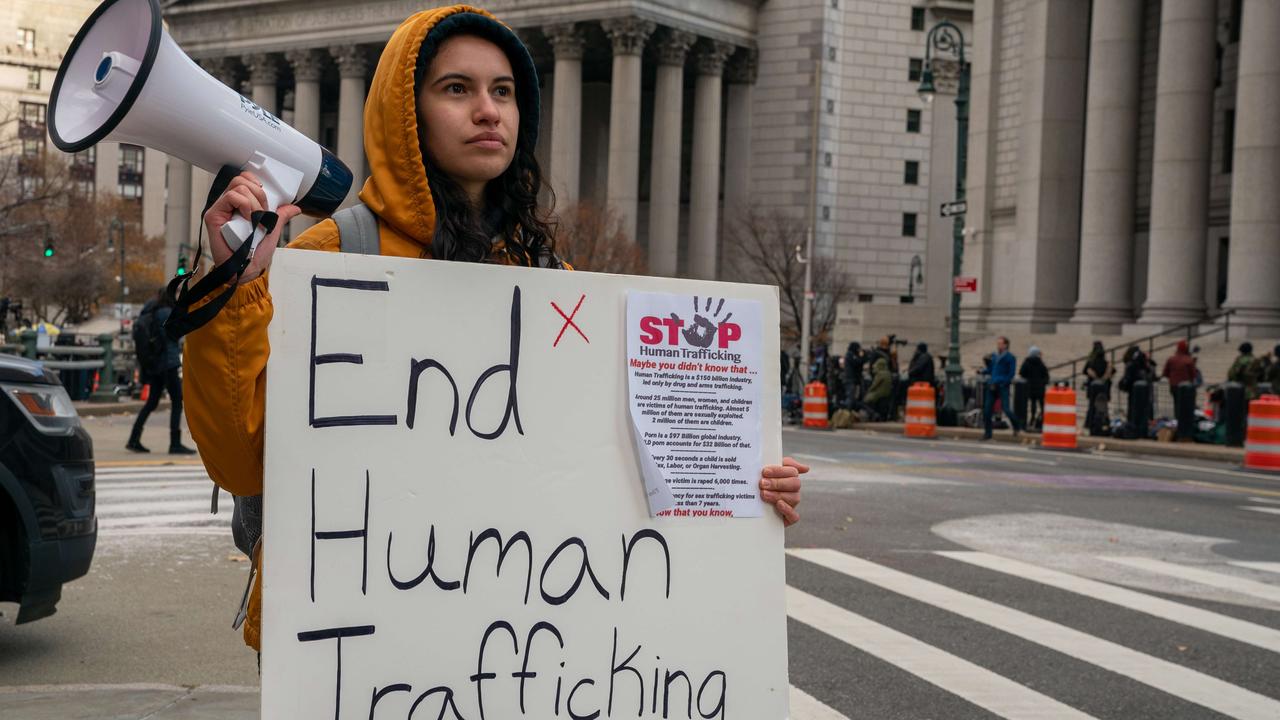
[[1225, 0, 1280, 338]]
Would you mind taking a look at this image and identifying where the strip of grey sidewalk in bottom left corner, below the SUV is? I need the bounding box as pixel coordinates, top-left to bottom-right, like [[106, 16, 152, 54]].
[[0, 683, 259, 720]]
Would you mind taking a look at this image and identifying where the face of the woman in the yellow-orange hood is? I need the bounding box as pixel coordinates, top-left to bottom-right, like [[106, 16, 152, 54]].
[[417, 35, 520, 204]]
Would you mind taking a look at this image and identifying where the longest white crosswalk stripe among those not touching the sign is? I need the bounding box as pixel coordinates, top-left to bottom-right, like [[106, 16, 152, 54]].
[[937, 551, 1280, 652]]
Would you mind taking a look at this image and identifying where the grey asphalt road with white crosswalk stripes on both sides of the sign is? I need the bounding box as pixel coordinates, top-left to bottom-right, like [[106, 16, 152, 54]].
[[0, 416, 1280, 720]]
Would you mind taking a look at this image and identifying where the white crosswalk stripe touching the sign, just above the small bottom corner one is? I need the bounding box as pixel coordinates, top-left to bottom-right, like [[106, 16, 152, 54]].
[[787, 586, 1089, 720]]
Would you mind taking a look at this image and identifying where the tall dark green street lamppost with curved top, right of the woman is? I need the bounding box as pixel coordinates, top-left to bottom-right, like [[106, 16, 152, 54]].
[[918, 20, 969, 414]]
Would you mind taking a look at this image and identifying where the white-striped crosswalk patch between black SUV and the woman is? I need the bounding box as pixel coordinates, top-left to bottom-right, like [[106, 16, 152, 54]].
[[96, 465, 232, 532]]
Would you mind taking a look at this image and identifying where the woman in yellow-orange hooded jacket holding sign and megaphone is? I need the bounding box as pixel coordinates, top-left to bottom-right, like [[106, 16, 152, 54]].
[[186, 5, 808, 648]]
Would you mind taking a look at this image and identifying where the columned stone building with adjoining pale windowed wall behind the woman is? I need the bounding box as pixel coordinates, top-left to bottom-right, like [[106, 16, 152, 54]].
[[157, 0, 972, 305]]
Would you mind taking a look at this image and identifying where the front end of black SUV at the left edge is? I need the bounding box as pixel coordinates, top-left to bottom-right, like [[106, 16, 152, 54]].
[[0, 355, 97, 625]]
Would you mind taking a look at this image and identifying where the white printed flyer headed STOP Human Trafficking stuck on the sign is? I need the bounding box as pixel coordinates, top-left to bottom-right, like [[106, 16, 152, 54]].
[[627, 291, 764, 518]]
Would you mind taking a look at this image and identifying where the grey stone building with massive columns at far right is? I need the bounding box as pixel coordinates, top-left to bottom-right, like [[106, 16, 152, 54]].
[[964, 0, 1280, 337]]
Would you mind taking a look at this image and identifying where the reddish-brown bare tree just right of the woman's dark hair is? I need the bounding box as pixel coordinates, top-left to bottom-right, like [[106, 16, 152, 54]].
[[556, 201, 648, 275]]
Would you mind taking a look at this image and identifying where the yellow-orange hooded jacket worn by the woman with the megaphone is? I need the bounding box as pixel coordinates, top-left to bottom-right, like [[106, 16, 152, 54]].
[[183, 5, 536, 650]]
